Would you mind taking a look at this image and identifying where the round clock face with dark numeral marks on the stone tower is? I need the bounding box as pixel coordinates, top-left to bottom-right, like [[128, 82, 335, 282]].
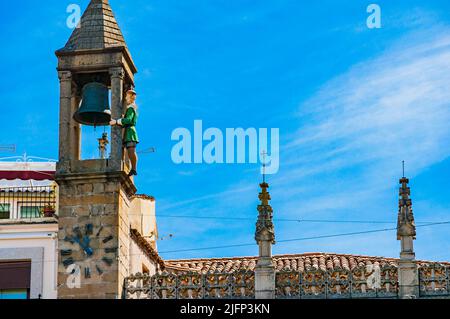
[[60, 224, 117, 279]]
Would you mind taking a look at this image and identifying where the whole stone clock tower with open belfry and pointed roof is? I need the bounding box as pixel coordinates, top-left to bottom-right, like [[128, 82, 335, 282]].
[[56, 0, 137, 298]]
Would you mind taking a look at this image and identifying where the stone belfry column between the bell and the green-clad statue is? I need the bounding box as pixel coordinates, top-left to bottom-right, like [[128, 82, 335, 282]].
[[109, 67, 125, 170]]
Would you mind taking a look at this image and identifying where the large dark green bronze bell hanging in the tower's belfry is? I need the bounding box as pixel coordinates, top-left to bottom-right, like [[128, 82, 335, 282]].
[[73, 82, 111, 126]]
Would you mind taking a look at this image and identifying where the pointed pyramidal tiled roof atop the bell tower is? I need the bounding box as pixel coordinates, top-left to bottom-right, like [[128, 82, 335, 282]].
[[59, 0, 127, 52]]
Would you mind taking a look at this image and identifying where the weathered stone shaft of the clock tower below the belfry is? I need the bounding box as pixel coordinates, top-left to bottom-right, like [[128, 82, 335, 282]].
[[58, 174, 134, 298]]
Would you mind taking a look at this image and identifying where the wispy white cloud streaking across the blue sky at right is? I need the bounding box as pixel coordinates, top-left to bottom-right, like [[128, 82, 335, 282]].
[[282, 30, 450, 188]]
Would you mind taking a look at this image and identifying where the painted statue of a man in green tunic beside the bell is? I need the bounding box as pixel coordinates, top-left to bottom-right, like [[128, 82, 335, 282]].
[[109, 89, 139, 176]]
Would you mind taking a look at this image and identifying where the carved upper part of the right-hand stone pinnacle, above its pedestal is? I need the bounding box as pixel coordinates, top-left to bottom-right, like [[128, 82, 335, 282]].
[[397, 177, 416, 240]]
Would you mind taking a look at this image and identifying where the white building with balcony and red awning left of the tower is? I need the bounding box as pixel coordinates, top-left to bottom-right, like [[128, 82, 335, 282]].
[[0, 161, 58, 299]]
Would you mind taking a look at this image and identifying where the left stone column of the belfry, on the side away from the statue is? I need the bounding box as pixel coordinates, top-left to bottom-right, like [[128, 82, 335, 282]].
[[58, 71, 73, 172]]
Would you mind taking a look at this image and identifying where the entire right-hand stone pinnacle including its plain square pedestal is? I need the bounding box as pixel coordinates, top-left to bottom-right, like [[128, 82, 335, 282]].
[[397, 177, 419, 299]]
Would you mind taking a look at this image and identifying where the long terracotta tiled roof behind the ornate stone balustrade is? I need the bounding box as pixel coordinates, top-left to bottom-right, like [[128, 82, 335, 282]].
[[165, 253, 450, 274]]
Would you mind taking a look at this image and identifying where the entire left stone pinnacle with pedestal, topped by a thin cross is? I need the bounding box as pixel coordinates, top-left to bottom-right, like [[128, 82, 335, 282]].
[[255, 182, 275, 299]]
